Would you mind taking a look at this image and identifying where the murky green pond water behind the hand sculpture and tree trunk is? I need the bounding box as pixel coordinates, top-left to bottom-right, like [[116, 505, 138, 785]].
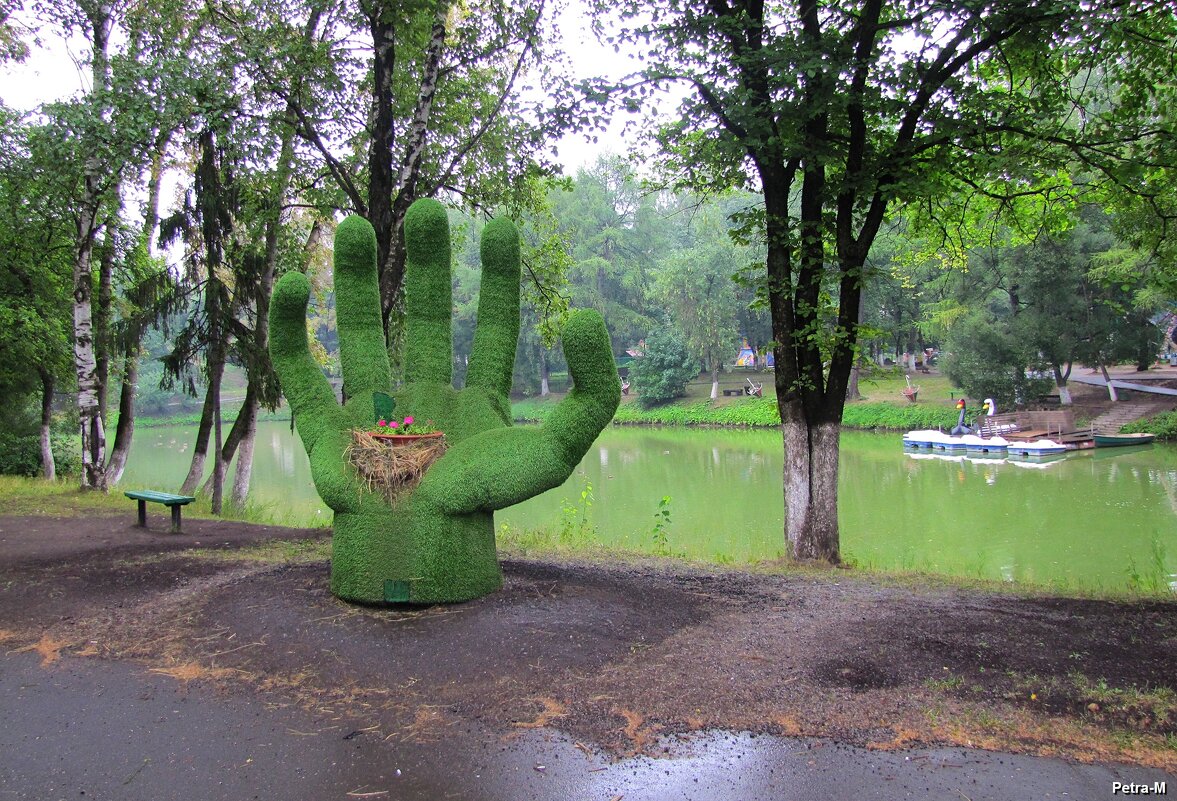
[[124, 422, 1177, 590]]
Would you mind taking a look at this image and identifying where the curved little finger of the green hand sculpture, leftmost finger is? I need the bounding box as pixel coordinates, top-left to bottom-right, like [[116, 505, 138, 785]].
[[270, 273, 340, 452]]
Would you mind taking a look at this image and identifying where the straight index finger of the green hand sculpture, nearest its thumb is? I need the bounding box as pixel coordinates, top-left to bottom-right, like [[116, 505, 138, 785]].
[[466, 219, 519, 398]]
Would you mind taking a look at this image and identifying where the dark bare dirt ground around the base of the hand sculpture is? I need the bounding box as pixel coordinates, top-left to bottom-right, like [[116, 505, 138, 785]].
[[0, 509, 1177, 773]]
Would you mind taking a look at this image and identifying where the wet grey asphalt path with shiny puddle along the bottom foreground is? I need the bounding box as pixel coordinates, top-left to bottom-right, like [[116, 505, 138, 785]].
[[0, 653, 1177, 801]]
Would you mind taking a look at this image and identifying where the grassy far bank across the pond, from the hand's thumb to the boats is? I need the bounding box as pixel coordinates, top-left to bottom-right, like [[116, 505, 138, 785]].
[[512, 372, 965, 430]]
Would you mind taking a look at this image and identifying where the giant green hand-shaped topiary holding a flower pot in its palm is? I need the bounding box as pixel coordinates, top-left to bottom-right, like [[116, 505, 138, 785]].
[[270, 200, 620, 603]]
